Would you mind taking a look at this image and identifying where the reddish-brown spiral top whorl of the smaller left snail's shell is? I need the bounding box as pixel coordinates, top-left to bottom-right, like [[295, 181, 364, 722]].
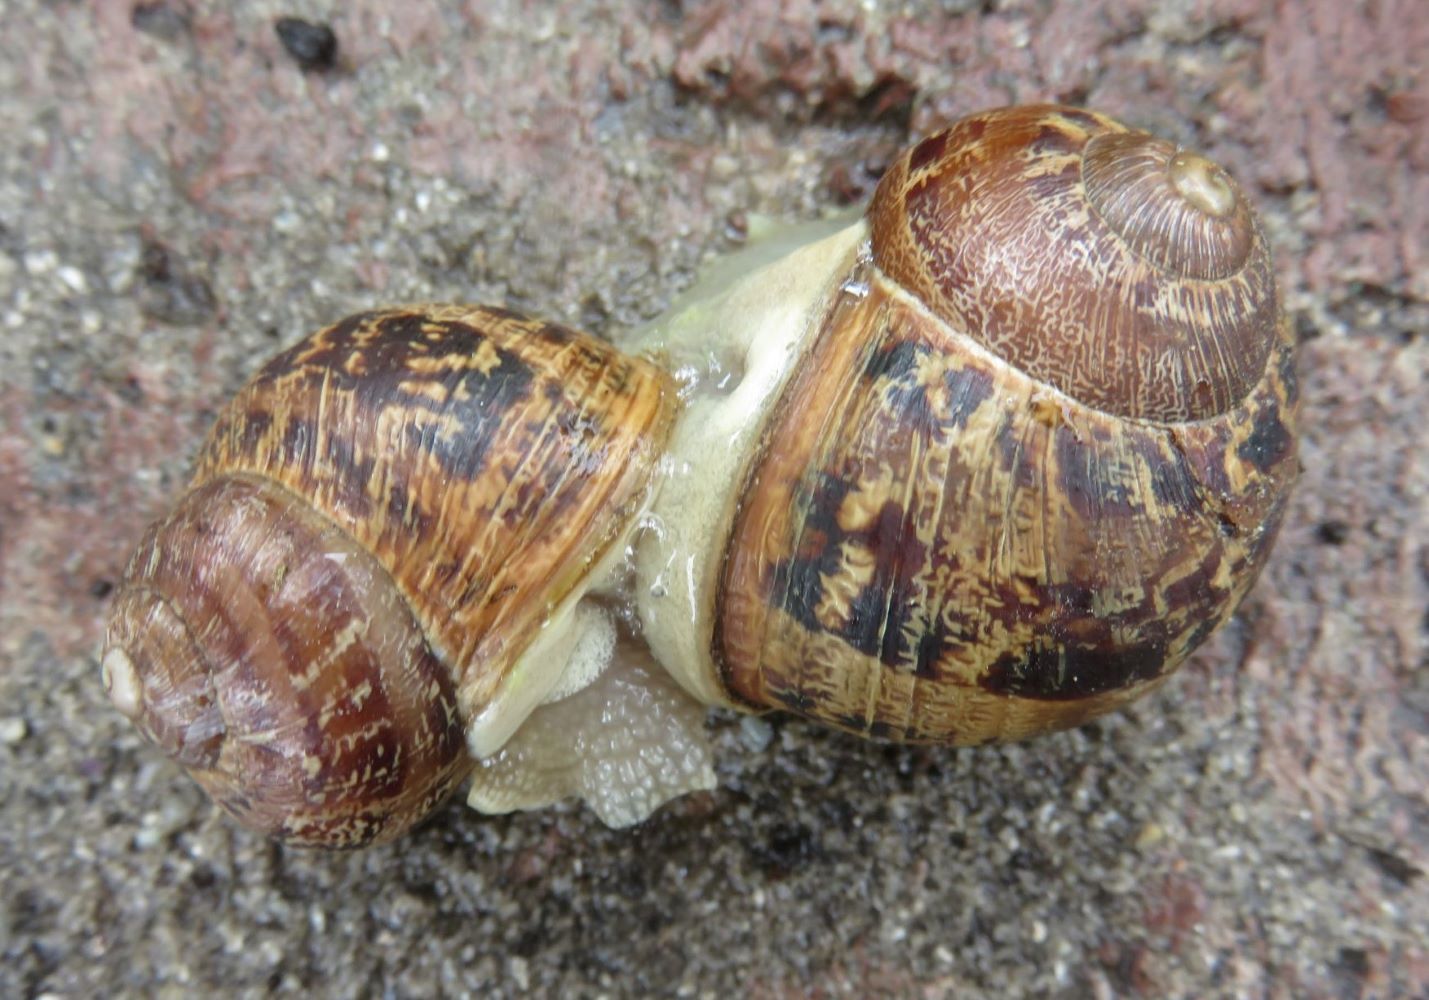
[[103, 476, 472, 847]]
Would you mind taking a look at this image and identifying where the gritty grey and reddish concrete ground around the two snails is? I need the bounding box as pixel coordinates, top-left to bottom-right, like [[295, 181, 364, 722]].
[[0, 0, 1429, 997]]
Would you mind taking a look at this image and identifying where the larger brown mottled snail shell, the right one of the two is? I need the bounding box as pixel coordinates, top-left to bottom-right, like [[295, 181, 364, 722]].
[[713, 107, 1298, 743]]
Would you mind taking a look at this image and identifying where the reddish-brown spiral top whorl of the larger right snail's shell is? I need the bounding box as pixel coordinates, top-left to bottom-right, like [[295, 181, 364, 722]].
[[869, 107, 1276, 423]]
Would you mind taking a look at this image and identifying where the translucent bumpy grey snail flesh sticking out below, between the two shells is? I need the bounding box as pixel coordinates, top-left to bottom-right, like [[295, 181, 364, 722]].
[[467, 639, 715, 827]]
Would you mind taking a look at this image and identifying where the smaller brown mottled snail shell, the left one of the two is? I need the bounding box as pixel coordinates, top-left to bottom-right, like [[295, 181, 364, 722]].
[[104, 307, 676, 847]]
